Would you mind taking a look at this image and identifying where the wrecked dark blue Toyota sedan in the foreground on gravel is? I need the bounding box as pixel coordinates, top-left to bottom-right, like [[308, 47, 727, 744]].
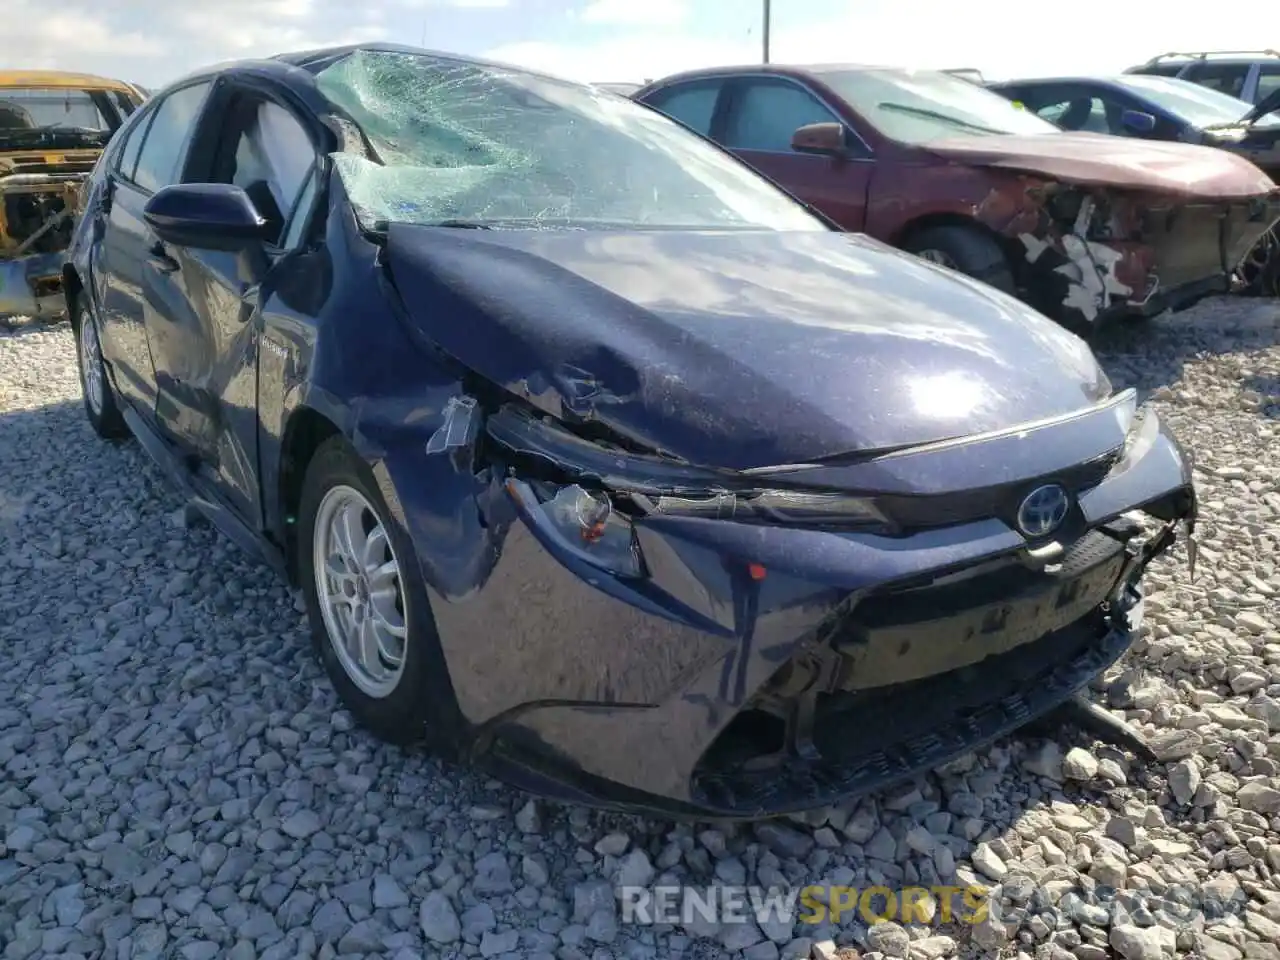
[[65, 45, 1197, 818]]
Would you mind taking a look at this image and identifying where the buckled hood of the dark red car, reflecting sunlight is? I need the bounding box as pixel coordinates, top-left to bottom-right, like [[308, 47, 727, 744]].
[[925, 132, 1276, 200]]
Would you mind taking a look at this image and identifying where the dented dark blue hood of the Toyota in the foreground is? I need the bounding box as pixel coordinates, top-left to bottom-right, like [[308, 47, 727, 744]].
[[388, 224, 1110, 470]]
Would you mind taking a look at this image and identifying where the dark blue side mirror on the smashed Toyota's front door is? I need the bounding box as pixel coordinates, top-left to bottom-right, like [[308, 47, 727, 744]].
[[142, 183, 266, 252]]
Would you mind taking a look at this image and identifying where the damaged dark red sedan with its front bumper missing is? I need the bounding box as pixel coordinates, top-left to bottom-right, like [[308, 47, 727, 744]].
[[635, 65, 1280, 334]]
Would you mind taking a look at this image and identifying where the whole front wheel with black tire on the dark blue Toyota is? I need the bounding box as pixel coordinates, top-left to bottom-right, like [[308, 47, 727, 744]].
[[297, 436, 452, 746]]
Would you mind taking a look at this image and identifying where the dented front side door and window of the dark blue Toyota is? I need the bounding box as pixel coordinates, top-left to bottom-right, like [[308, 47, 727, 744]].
[[156, 82, 320, 529]]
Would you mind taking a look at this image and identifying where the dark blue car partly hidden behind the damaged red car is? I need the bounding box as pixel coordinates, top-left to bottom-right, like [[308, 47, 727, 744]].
[[988, 74, 1280, 297]]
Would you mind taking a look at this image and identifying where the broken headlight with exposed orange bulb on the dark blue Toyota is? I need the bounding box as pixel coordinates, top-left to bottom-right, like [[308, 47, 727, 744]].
[[507, 480, 644, 577]]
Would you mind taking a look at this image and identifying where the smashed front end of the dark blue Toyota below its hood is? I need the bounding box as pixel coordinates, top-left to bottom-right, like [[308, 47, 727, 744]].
[[384, 393, 1196, 818]]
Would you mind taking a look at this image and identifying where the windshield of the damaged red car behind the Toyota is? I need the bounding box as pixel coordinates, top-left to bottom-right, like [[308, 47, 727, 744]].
[[815, 69, 1061, 145]]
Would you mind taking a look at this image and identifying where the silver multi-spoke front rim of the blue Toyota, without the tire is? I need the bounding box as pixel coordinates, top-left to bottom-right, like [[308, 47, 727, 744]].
[[311, 485, 408, 699]]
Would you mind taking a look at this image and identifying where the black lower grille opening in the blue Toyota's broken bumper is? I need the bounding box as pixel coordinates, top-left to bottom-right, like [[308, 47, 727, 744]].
[[696, 522, 1135, 812]]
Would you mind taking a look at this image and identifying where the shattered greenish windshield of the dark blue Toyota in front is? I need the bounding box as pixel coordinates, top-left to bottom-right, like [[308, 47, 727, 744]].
[[316, 50, 828, 230]]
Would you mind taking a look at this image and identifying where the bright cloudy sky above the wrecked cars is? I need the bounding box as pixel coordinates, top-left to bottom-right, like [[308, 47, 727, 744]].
[[0, 0, 1274, 86]]
